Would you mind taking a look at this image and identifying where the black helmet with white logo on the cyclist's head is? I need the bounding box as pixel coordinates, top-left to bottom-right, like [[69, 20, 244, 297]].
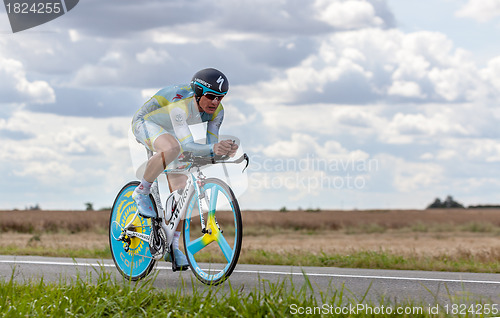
[[191, 68, 229, 101]]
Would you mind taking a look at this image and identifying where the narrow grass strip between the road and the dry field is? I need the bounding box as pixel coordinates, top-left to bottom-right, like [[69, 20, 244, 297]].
[[0, 246, 500, 273]]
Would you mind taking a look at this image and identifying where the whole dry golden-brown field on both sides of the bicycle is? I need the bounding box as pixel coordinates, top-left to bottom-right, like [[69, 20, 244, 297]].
[[0, 209, 500, 270]]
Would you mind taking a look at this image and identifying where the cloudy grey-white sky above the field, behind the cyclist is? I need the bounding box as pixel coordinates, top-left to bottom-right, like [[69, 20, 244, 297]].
[[0, 0, 500, 210]]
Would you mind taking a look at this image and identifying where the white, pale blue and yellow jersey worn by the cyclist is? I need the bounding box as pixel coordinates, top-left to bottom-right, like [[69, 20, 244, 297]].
[[132, 85, 224, 156]]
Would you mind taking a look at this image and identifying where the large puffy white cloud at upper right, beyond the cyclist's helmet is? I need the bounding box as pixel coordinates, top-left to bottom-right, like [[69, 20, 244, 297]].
[[250, 28, 498, 104]]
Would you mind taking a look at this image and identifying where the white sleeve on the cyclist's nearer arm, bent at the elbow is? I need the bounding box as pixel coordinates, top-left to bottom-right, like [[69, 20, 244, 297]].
[[170, 107, 214, 157]]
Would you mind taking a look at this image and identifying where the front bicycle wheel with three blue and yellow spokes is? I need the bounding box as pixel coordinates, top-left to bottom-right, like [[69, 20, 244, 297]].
[[184, 178, 243, 285]]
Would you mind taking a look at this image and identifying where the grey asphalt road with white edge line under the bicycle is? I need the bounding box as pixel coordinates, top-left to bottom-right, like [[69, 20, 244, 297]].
[[0, 255, 500, 309]]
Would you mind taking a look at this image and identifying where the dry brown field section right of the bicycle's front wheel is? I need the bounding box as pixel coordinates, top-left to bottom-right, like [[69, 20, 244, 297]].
[[244, 209, 500, 264]]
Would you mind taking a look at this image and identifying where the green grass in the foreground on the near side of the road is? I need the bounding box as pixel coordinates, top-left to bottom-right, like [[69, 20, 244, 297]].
[[0, 269, 473, 317]]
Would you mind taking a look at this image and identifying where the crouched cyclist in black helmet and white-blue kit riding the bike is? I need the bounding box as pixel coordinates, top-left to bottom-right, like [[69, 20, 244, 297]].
[[132, 68, 238, 269]]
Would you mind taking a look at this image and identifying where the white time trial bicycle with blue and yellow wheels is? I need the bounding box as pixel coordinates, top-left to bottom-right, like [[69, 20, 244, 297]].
[[109, 150, 249, 285]]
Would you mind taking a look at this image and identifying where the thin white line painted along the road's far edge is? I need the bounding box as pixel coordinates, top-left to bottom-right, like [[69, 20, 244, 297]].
[[0, 260, 500, 285]]
